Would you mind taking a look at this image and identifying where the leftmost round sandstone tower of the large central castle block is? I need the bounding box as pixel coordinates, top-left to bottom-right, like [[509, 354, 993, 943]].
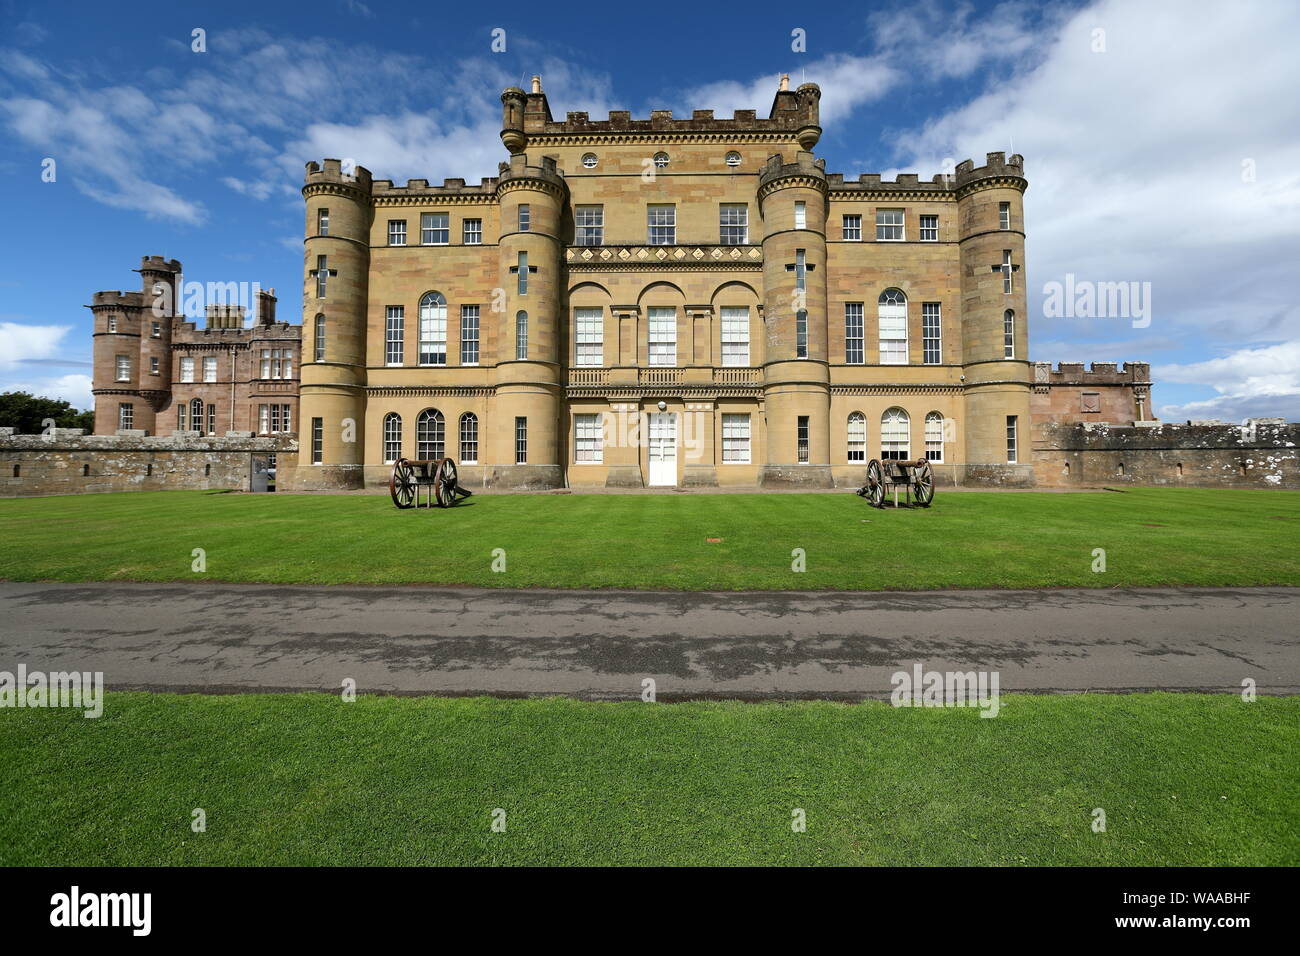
[[299, 159, 373, 488]]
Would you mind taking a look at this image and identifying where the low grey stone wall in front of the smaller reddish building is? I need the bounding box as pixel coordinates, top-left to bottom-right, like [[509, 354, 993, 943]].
[[0, 428, 298, 497]]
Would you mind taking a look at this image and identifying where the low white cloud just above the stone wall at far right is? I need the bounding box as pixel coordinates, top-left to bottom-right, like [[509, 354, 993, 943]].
[[1152, 342, 1300, 421]]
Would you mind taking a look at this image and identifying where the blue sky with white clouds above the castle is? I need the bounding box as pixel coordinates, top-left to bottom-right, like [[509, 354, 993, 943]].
[[0, 0, 1300, 420]]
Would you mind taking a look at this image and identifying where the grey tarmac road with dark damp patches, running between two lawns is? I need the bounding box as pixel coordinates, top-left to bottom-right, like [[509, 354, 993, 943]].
[[0, 581, 1300, 700]]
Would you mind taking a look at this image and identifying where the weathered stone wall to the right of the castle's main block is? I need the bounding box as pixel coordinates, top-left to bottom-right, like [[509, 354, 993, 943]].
[[1034, 419, 1300, 489]]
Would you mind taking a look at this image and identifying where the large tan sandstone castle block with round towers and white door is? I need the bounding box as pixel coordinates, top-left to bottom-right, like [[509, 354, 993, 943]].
[[298, 77, 1032, 488]]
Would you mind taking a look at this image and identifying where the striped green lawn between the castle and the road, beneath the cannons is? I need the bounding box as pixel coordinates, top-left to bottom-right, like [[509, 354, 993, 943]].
[[0, 489, 1300, 589]]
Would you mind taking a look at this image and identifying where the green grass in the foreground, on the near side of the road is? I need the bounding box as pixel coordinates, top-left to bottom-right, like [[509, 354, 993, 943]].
[[0, 693, 1300, 865]]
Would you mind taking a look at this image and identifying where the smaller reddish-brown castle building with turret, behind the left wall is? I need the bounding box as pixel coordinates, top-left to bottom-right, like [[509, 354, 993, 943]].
[[87, 256, 302, 436]]
